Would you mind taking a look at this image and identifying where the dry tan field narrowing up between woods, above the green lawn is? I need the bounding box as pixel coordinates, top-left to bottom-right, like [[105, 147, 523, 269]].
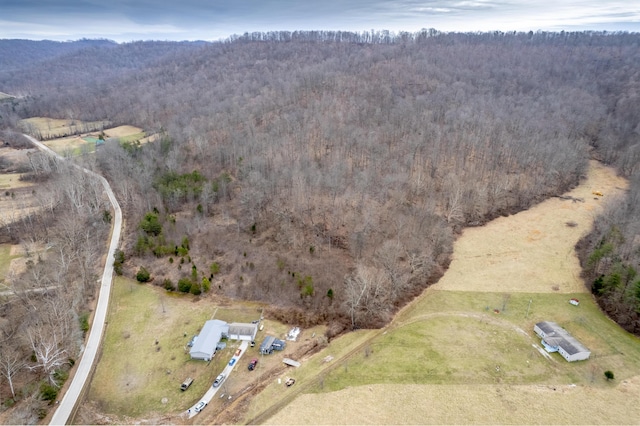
[[433, 162, 627, 293]]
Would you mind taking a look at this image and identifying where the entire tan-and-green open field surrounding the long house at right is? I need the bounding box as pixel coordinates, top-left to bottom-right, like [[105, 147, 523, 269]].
[[249, 163, 640, 424]]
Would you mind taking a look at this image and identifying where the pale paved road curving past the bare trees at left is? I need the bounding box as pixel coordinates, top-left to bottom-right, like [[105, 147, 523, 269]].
[[25, 135, 122, 425]]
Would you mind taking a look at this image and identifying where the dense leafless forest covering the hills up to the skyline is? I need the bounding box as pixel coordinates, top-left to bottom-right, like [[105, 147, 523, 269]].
[[0, 30, 640, 420]]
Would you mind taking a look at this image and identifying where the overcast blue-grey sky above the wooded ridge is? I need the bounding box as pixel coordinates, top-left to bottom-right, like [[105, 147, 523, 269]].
[[0, 0, 640, 42]]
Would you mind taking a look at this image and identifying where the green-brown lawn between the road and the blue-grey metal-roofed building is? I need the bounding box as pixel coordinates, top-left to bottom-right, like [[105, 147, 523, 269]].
[[87, 277, 259, 419]]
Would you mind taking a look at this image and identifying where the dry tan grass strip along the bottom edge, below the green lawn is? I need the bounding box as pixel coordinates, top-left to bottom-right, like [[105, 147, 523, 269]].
[[267, 377, 640, 424]]
